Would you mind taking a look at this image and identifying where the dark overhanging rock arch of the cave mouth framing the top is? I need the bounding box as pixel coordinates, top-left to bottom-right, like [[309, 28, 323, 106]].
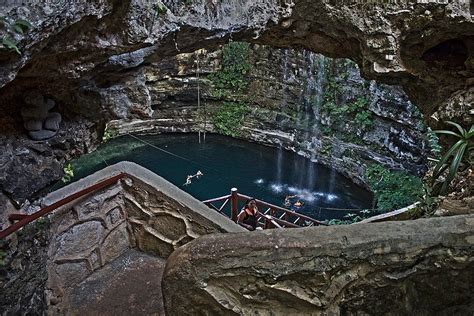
[[0, 0, 474, 199]]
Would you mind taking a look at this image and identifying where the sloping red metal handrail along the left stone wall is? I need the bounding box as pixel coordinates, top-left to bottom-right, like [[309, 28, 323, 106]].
[[0, 173, 126, 239]]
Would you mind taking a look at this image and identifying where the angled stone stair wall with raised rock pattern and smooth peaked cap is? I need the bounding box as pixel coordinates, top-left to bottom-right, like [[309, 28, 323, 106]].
[[43, 162, 245, 310]]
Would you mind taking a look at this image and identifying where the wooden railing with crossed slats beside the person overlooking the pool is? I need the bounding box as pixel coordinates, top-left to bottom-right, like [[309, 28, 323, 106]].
[[203, 188, 326, 229]]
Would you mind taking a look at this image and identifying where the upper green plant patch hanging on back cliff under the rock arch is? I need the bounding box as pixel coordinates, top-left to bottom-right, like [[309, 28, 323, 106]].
[[210, 42, 252, 97]]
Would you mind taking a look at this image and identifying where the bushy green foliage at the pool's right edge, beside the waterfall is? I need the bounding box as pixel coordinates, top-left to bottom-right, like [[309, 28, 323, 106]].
[[365, 165, 424, 211]]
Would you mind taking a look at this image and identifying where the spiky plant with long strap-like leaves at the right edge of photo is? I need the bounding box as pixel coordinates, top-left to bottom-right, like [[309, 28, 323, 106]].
[[433, 121, 474, 195]]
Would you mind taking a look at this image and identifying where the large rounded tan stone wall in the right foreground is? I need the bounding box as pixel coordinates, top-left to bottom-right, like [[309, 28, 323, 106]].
[[162, 215, 474, 315]]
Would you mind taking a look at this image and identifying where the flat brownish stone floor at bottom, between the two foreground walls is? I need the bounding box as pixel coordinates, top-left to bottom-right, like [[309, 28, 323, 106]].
[[68, 249, 166, 315]]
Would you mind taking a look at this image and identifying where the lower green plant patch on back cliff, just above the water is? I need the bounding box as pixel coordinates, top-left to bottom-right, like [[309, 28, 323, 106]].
[[212, 102, 250, 137]]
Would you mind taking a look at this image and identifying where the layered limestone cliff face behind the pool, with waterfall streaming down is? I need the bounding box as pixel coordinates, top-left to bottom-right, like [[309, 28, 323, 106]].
[[111, 45, 426, 184]]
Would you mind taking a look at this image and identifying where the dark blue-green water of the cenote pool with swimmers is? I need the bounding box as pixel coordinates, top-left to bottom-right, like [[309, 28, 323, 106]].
[[65, 134, 373, 220]]
